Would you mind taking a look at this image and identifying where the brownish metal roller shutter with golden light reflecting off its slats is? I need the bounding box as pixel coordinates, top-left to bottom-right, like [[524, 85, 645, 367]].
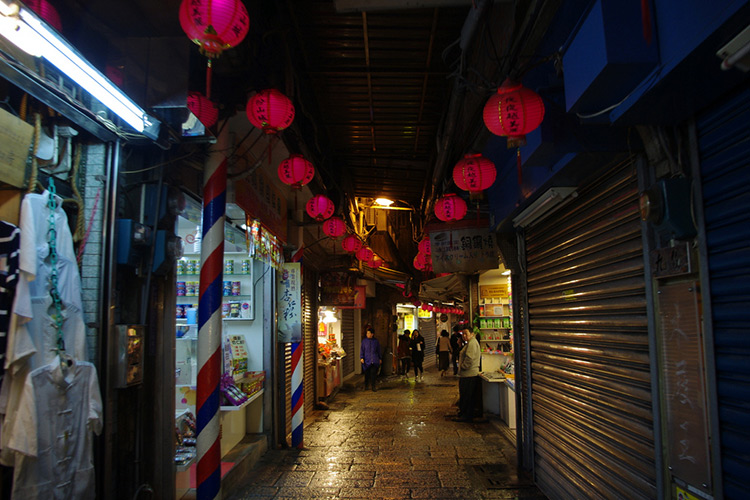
[[526, 162, 657, 500]]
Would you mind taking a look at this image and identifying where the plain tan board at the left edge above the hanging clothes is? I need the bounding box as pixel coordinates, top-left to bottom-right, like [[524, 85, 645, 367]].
[[0, 108, 34, 187]]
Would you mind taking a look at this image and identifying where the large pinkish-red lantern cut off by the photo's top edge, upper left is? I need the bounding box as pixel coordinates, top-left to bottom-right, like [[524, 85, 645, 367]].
[[180, 0, 250, 59]]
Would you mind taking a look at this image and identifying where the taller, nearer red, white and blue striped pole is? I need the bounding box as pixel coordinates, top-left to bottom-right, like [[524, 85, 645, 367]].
[[196, 123, 228, 500]]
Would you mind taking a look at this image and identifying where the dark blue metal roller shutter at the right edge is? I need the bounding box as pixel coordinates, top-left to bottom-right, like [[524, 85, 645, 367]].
[[697, 89, 750, 498]]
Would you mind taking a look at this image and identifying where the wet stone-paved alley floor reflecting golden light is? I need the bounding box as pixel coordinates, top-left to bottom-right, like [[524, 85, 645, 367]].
[[224, 367, 546, 500]]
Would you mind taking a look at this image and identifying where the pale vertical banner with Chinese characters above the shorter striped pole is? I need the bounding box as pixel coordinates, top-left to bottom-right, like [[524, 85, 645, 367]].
[[276, 262, 302, 342]]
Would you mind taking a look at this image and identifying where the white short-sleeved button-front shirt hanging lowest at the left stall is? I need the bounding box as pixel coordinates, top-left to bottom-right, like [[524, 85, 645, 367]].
[[8, 358, 102, 500]]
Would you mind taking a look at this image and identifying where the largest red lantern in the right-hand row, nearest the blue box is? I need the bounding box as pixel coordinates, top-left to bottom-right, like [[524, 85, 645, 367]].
[[483, 79, 544, 148]]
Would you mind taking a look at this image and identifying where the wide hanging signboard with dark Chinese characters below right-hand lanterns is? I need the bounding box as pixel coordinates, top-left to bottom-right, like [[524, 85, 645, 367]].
[[430, 228, 498, 273]]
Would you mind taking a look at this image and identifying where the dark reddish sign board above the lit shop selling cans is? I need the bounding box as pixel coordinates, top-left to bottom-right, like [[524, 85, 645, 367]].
[[234, 170, 287, 242]]
